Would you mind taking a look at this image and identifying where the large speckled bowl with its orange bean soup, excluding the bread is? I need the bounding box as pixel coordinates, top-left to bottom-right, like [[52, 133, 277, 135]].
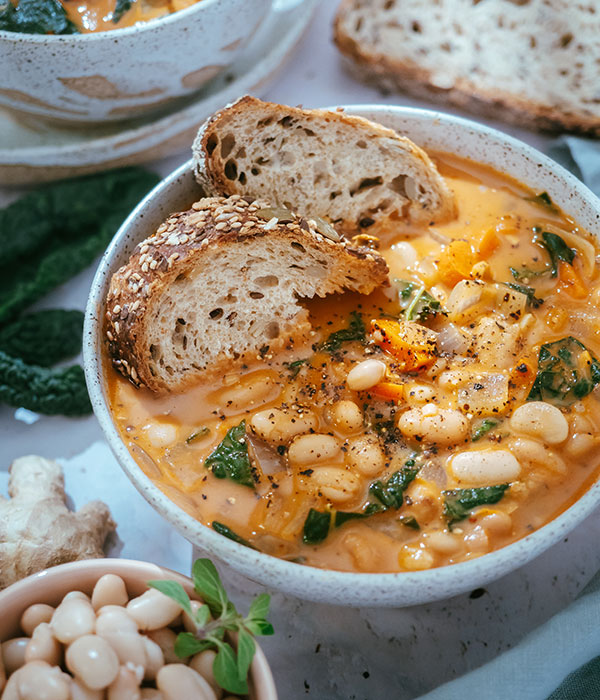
[[84, 107, 600, 606]]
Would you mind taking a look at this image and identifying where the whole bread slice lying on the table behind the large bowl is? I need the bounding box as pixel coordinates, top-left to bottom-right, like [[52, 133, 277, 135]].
[[334, 0, 600, 136]]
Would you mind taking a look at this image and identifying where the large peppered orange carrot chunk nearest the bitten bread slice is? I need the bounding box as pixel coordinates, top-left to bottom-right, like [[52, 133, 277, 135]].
[[371, 319, 437, 372]]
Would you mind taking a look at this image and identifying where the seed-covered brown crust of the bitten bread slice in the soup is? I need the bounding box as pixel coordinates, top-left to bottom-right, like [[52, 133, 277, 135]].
[[104, 195, 389, 392]]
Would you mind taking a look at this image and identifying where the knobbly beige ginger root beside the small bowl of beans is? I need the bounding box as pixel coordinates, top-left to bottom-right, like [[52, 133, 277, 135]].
[[0, 455, 116, 589]]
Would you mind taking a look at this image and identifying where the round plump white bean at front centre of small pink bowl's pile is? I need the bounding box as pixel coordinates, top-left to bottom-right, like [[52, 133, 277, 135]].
[[65, 634, 119, 690]]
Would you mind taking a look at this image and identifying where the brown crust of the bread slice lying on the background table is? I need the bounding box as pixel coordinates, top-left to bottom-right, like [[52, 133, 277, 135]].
[[333, 0, 600, 137]]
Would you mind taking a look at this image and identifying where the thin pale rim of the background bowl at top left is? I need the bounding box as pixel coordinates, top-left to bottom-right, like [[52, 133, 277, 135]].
[[0, 0, 244, 45]]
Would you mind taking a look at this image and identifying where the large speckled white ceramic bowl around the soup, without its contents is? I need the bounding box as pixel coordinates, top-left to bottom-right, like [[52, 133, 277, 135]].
[[84, 106, 600, 606]]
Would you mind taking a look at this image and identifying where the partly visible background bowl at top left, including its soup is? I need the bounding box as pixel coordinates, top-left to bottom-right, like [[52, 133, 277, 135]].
[[0, 0, 271, 124]]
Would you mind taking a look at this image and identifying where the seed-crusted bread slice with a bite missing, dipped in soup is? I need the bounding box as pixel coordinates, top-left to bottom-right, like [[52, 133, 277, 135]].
[[106, 195, 387, 392]]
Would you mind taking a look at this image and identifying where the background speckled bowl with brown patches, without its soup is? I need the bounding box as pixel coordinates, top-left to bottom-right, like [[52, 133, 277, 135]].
[[0, 0, 272, 123]]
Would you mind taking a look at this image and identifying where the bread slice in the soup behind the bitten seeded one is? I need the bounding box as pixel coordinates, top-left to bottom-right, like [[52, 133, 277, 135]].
[[193, 97, 455, 235]]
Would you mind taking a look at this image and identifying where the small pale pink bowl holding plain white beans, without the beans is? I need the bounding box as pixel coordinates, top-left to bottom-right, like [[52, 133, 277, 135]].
[[0, 559, 277, 700]]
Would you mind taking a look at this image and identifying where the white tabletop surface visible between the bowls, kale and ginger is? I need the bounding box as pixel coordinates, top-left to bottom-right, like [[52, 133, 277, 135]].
[[0, 0, 600, 700]]
